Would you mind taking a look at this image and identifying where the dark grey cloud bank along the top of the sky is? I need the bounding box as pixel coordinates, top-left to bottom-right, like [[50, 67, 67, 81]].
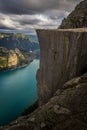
[[0, 0, 81, 14]]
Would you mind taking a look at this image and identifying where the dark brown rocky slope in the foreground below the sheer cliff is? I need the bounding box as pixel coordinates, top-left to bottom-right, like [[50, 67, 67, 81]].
[[0, 73, 87, 130]]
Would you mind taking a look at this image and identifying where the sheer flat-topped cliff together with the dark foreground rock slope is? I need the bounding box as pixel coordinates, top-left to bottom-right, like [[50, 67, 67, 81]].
[[0, 28, 87, 130]]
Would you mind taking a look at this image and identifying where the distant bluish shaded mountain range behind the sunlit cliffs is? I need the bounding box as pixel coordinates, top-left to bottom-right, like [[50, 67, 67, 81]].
[[0, 33, 39, 52]]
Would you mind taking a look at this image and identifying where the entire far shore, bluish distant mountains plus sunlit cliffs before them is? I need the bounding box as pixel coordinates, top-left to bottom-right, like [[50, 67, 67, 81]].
[[0, 33, 40, 71]]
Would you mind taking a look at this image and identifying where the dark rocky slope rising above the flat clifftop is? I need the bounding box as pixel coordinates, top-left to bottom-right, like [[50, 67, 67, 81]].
[[59, 0, 87, 29]]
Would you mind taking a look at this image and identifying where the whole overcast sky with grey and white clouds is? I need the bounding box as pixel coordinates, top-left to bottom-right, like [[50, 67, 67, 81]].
[[0, 0, 82, 34]]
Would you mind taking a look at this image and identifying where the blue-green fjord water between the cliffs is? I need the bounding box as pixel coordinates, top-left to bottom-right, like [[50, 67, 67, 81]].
[[0, 60, 39, 125]]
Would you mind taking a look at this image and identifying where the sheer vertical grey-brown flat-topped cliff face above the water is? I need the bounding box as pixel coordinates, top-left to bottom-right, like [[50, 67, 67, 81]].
[[37, 28, 87, 105]]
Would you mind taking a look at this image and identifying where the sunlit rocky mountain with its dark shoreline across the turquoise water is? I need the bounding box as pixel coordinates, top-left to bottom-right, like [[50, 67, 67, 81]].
[[0, 47, 35, 71]]
